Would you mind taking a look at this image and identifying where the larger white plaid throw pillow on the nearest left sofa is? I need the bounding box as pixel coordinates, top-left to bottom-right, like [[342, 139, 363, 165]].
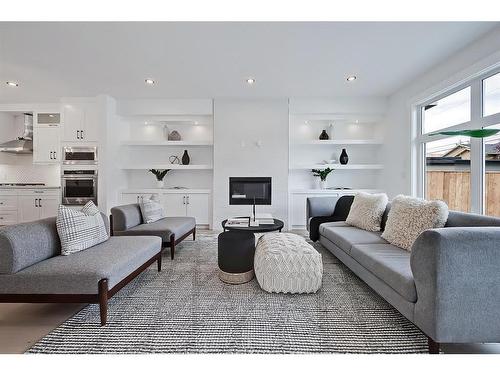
[[56, 201, 109, 255]]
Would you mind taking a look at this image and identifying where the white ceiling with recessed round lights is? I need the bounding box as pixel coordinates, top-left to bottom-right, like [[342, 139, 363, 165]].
[[0, 22, 499, 102]]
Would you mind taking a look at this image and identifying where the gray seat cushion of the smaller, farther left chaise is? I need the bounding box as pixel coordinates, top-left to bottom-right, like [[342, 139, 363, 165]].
[[114, 216, 196, 242]]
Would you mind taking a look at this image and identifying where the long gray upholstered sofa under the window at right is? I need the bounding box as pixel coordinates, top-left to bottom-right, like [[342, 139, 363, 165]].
[[306, 197, 500, 353]]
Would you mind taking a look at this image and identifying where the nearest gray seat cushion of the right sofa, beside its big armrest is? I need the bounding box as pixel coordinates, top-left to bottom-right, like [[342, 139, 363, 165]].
[[350, 244, 417, 302]]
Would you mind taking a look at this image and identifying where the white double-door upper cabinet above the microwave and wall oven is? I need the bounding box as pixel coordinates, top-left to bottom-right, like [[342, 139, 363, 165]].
[[62, 102, 99, 142]]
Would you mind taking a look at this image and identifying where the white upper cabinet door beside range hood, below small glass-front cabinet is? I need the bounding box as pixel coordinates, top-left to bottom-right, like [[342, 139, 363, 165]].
[[33, 124, 61, 164]]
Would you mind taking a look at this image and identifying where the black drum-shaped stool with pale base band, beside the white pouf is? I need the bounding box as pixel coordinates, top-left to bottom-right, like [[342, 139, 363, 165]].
[[218, 230, 255, 284]]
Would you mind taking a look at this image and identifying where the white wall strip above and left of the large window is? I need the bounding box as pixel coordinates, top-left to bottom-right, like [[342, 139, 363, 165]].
[[382, 28, 500, 197]]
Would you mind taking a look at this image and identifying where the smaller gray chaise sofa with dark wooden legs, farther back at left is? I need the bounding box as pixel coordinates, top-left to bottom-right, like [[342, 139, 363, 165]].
[[110, 203, 196, 259]]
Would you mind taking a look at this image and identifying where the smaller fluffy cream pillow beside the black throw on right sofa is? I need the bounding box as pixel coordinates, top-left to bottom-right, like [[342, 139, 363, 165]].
[[345, 193, 388, 232]]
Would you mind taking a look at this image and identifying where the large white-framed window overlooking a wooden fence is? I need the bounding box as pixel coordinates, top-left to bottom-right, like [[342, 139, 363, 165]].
[[415, 66, 500, 217]]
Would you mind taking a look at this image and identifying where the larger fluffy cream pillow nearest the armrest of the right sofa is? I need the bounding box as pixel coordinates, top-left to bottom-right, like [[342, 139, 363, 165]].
[[382, 195, 448, 251]]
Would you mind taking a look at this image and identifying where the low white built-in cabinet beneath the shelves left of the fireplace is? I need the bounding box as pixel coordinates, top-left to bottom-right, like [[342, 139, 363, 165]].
[[121, 189, 211, 225]]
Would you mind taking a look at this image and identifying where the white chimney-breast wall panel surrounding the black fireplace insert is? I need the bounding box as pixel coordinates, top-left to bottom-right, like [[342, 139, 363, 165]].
[[213, 98, 288, 229]]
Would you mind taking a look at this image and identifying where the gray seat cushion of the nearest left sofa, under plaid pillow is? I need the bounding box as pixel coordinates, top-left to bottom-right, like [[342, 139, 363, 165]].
[[0, 236, 161, 294]]
